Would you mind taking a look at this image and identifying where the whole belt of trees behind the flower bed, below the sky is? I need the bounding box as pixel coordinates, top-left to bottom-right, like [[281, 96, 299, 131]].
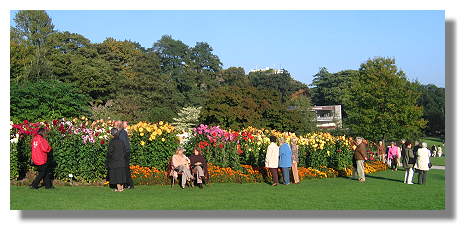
[[10, 11, 444, 139]]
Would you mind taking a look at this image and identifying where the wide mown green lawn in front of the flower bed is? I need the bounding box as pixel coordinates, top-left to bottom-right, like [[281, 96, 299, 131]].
[[10, 170, 445, 210]]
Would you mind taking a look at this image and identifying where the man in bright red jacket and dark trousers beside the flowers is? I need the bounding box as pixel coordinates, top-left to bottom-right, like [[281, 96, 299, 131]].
[[30, 128, 53, 189]]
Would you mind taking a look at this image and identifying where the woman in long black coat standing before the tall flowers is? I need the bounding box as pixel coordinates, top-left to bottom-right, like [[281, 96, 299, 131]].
[[106, 128, 129, 192]]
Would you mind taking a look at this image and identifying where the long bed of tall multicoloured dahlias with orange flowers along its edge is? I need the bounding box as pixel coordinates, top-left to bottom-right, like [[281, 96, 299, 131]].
[[10, 117, 386, 184]]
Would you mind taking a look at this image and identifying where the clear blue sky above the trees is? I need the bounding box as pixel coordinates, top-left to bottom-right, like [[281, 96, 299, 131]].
[[10, 11, 445, 87]]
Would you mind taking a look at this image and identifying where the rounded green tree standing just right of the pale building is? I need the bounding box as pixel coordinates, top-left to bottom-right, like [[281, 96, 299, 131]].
[[346, 57, 426, 140]]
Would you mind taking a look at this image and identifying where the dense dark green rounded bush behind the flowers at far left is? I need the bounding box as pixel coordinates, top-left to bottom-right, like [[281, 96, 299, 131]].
[[10, 80, 89, 123]]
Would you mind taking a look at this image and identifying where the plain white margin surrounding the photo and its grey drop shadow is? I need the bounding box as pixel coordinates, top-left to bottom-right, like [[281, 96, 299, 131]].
[[0, 0, 470, 235]]
